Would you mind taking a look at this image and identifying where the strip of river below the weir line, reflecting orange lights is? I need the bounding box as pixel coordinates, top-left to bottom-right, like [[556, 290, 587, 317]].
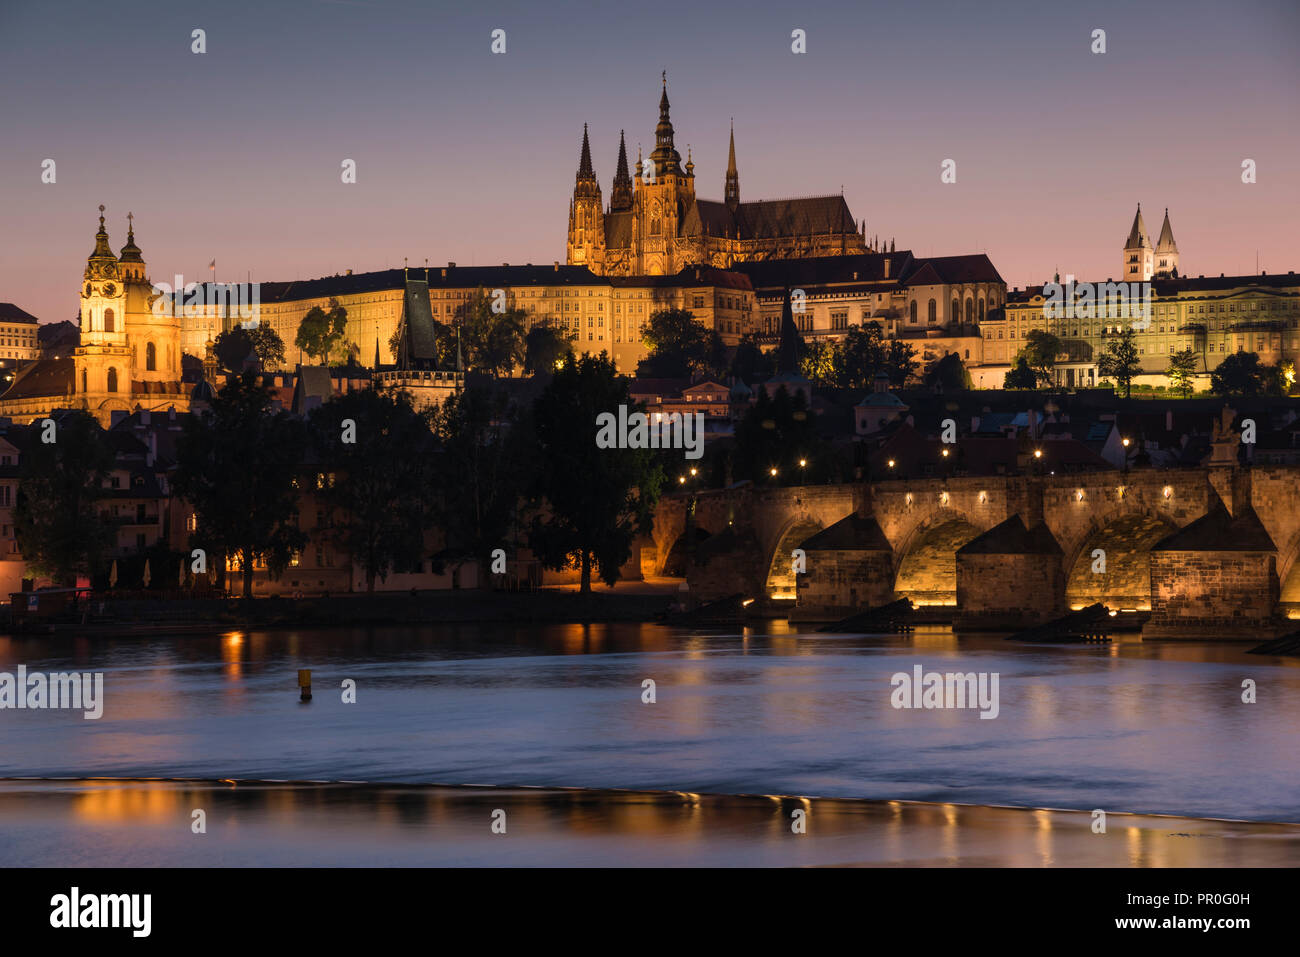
[[0, 779, 1300, 867]]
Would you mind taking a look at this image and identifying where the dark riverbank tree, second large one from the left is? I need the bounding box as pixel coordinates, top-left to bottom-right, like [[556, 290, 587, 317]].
[[173, 372, 307, 598]]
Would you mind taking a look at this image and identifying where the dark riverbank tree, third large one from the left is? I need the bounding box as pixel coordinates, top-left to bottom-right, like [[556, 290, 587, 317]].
[[311, 389, 436, 593]]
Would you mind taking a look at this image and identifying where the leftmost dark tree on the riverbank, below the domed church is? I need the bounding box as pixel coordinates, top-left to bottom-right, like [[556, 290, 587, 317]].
[[13, 411, 113, 585]]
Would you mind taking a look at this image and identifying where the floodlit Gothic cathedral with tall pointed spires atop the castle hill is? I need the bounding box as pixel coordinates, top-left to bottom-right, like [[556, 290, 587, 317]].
[[568, 74, 872, 276]]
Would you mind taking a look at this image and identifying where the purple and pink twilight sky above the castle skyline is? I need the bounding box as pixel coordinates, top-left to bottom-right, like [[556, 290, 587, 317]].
[[0, 0, 1300, 321]]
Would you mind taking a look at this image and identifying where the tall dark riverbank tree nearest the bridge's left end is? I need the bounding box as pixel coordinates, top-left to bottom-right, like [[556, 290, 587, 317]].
[[529, 355, 663, 593]]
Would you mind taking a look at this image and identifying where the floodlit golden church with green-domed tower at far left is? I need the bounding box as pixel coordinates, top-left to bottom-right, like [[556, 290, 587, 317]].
[[0, 205, 190, 428]]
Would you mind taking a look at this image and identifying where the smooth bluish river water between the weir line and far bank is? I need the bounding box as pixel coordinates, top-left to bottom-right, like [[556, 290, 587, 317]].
[[0, 623, 1300, 822]]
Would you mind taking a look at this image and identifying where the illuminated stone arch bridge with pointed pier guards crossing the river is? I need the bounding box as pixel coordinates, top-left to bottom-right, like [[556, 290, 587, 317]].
[[644, 465, 1300, 638]]
